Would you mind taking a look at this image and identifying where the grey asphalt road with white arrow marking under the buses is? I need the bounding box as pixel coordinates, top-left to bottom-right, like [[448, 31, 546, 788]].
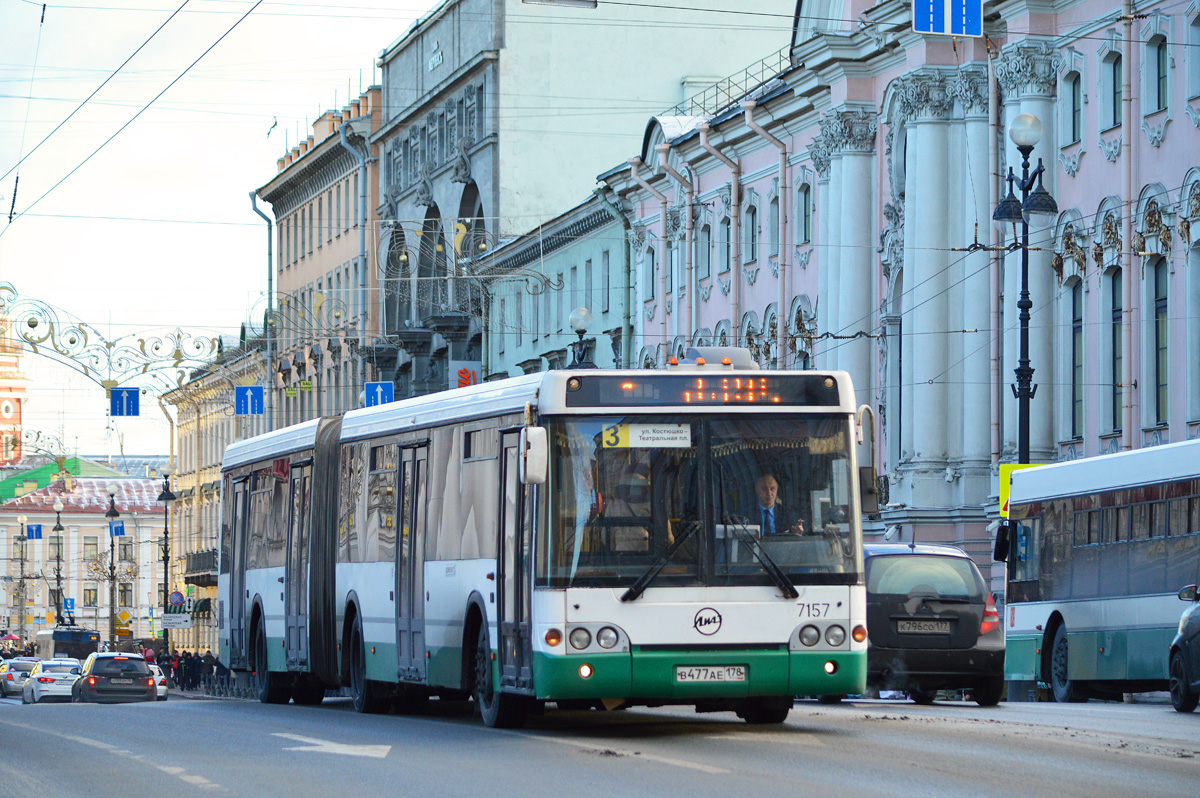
[[0, 695, 1200, 798]]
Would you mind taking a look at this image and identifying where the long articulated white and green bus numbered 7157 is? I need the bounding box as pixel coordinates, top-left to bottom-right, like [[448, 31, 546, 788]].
[[218, 349, 874, 726]]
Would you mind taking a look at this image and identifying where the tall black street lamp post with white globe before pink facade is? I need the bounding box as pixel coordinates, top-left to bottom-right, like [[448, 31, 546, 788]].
[[991, 114, 1058, 464]]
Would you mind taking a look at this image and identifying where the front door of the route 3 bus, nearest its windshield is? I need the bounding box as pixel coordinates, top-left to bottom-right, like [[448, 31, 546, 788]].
[[496, 431, 533, 689]]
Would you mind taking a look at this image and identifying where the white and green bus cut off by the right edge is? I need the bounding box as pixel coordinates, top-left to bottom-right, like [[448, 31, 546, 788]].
[[1004, 440, 1200, 702]]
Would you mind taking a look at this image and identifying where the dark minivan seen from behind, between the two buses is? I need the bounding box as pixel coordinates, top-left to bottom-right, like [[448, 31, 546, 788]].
[[863, 544, 1004, 707]]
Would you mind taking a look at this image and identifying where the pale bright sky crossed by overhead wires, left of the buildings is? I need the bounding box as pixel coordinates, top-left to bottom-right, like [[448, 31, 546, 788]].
[[0, 0, 434, 455]]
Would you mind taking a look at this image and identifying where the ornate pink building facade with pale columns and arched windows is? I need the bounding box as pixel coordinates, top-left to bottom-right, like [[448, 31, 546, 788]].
[[600, 0, 1200, 562]]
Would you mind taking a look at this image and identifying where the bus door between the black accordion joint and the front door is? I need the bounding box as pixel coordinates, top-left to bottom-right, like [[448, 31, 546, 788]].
[[396, 444, 428, 682]]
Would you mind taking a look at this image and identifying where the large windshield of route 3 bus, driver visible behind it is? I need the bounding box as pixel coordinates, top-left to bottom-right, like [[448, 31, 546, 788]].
[[538, 414, 859, 587]]
